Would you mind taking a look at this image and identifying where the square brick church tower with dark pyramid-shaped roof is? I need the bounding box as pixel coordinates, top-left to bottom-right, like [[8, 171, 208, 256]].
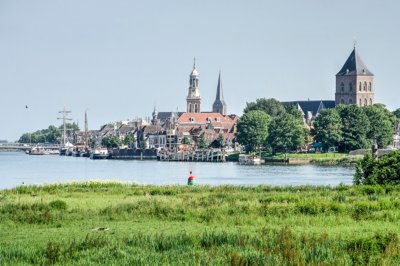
[[335, 46, 375, 107]]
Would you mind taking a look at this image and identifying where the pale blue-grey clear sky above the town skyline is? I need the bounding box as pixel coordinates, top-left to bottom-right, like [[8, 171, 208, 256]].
[[0, 0, 400, 141]]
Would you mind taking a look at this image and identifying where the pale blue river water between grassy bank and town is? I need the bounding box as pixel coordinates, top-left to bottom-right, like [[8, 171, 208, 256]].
[[0, 152, 354, 189]]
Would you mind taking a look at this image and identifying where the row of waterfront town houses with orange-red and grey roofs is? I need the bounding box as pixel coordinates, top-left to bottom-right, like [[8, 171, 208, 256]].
[[73, 110, 239, 150]]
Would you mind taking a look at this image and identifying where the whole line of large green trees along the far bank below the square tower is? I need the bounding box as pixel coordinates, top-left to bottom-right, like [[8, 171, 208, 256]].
[[237, 98, 400, 153]]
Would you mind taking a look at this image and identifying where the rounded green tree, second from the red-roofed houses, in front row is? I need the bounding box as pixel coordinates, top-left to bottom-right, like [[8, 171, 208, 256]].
[[267, 113, 306, 151]]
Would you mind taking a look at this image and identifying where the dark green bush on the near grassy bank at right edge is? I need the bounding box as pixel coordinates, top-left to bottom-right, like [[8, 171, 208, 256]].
[[354, 150, 400, 185]]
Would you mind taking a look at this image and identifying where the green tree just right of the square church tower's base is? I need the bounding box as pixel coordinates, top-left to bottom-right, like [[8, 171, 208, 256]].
[[363, 105, 394, 148]]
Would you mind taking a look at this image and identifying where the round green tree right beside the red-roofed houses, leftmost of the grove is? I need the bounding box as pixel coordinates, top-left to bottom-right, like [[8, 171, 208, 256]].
[[236, 110, 271, 151]]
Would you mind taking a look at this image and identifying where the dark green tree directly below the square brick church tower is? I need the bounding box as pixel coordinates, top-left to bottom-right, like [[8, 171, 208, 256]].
[[336, 105, 372, 151]]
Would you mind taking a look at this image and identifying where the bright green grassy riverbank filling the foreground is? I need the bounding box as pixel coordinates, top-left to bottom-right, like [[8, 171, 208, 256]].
[[0, 183, 400, 265]]
